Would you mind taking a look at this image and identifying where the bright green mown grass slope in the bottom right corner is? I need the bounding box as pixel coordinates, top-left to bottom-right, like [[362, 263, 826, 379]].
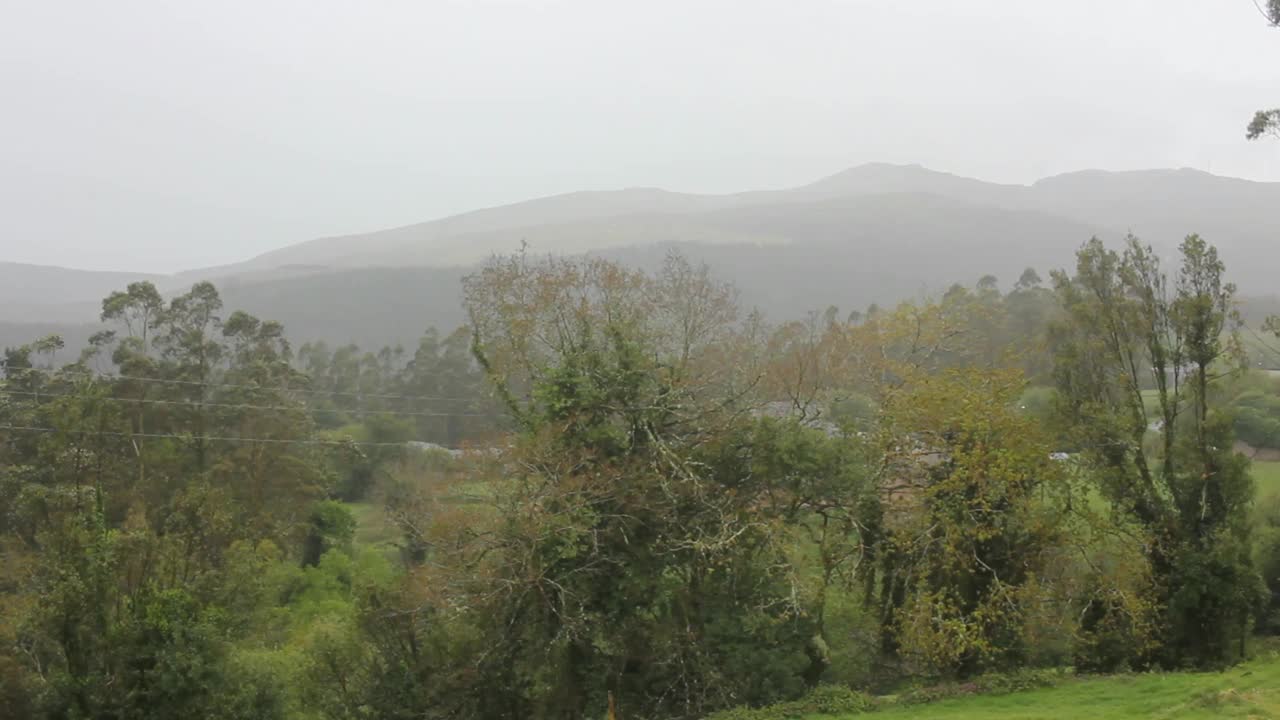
[[824, 652, 1280, 720]]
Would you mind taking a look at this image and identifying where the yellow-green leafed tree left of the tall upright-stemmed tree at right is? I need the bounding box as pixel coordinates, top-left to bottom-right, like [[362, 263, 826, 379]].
[[876, 369, 1066, 676]]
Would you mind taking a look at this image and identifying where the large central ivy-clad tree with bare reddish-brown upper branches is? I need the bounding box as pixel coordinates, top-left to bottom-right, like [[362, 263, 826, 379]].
[[440, 256, 820, 719]]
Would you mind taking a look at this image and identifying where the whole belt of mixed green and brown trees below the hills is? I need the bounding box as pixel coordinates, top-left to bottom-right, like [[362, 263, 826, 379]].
[[0, 237, 1280, 719]]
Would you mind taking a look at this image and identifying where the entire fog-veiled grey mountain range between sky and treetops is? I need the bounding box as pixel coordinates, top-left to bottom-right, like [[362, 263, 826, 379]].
[[0, 164, 1280, 346]]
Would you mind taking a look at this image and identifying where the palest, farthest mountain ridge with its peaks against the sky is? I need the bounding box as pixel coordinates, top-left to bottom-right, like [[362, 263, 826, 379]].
[[183, 164, 1280, 284]]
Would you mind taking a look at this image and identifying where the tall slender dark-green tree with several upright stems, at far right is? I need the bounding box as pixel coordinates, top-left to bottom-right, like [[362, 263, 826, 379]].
[[1052, 236, 1260, 666]]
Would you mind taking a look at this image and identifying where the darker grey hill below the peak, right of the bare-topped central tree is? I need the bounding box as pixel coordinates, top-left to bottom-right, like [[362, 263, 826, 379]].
[[604, 192, 1102, 318]]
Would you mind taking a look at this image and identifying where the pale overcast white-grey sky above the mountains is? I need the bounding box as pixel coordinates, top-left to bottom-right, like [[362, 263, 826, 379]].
[[0, 0, 1280, 272]]
